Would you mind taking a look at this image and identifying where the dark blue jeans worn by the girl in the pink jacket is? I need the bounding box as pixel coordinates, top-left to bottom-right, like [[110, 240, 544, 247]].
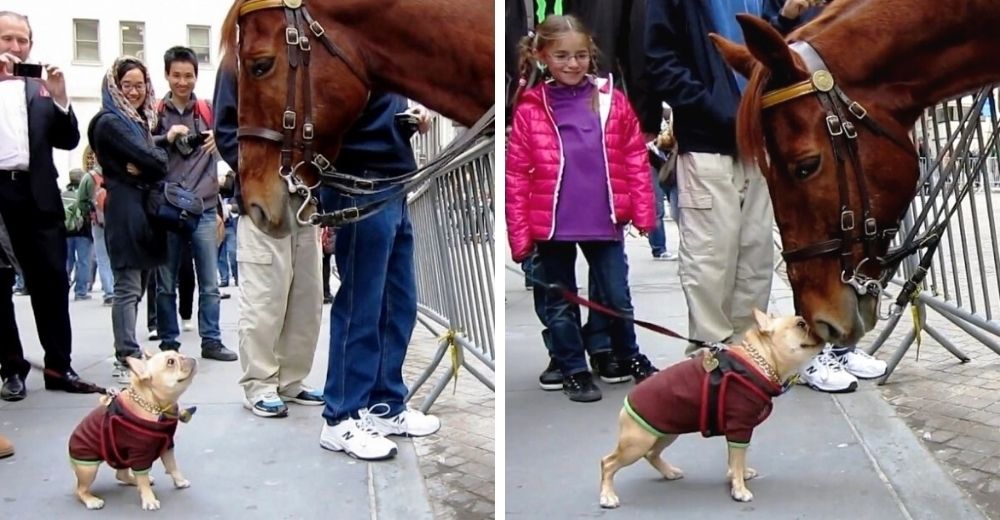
[[538, 240, 639, 376]]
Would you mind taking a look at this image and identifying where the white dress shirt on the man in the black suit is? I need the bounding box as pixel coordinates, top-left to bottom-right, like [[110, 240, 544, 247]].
[[0, 78, 69, 171]]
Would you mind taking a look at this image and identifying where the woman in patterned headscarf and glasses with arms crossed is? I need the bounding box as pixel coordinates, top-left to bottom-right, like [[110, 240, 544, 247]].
[[87, 56, 167, 382]]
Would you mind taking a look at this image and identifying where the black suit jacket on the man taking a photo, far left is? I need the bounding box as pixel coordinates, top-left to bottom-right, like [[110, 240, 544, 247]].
[[25, 79, 80, 221]]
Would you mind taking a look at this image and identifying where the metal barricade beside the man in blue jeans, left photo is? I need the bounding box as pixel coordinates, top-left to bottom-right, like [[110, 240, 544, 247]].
[[407, 126, 496, 412]]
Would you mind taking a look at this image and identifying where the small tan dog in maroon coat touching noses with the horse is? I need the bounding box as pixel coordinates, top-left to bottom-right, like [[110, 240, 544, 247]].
[[601, 309, 823, 508]]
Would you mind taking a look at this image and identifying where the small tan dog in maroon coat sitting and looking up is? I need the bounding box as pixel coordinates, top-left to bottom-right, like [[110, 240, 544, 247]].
[[69, 350, 198, 510]]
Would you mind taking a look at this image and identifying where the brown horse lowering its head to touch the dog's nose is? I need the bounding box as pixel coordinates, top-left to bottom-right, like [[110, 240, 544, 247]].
[[713, 0, 1000, 344]]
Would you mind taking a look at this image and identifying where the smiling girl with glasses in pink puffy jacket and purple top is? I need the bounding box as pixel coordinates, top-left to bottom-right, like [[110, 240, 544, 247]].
[[506, 16, 656, 402]]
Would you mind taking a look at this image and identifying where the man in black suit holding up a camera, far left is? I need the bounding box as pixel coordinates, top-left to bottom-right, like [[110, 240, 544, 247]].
[[0, 11, 90, 401]]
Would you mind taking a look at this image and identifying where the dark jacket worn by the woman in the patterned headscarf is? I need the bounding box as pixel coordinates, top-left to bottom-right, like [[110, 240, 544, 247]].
[[87, 111, 167, 269]]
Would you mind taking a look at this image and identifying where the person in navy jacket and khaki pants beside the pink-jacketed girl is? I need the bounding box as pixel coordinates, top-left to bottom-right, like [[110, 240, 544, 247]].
[[645, 0, 774, 353]]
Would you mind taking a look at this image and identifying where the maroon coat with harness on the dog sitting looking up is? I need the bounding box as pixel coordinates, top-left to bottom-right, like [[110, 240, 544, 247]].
[[69, 396, 177, 474]]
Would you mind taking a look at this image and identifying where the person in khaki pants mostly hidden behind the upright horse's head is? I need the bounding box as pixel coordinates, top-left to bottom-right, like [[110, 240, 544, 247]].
[[214, 69, 323, 417]]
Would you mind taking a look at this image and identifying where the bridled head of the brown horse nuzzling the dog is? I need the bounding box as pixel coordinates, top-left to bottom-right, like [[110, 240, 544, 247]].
[[712, 15, 919, 344]]
